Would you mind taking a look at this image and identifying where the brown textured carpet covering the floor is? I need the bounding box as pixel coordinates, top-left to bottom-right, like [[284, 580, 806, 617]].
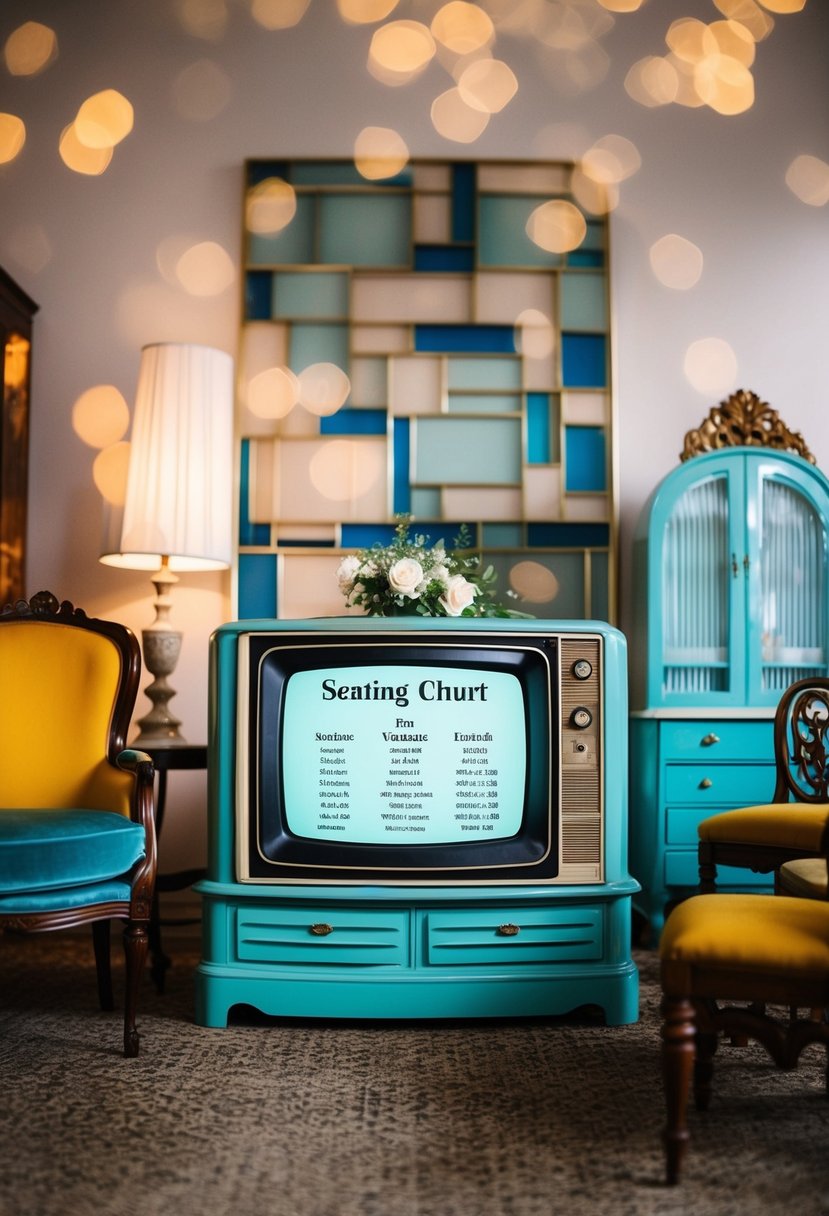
[[0, 934, 829, 1216]]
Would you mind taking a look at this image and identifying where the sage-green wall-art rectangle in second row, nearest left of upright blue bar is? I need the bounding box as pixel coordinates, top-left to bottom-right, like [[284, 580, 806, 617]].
[[320, 193, 412, 269]]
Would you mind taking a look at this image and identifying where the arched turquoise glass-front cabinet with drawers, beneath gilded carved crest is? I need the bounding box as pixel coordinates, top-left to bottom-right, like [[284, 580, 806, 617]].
[[630, 446, 829, 935]]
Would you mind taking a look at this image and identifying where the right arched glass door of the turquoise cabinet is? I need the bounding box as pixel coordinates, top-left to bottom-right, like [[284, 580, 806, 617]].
[[748, 469, 828, 704]]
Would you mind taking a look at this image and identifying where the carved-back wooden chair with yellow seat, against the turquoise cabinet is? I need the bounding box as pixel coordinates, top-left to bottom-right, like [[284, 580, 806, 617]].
[[698, 676, 829, 894]]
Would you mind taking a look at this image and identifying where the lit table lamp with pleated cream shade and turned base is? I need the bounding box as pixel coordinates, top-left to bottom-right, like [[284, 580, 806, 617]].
[[101, 343, 233, 747]]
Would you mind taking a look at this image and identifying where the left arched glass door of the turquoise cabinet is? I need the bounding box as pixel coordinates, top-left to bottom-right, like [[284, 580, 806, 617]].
[[661, 471, 744, 704]]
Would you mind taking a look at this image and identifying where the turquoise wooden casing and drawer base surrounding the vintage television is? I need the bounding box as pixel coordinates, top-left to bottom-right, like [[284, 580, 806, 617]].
[[196, 618, 638, 1026]]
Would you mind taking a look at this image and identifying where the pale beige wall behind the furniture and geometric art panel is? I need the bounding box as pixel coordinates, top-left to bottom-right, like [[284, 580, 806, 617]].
[[0, 0, 829, 869]]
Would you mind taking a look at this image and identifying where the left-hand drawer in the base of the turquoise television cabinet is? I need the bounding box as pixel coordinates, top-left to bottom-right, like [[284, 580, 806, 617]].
[[236, 905, 410, 967]]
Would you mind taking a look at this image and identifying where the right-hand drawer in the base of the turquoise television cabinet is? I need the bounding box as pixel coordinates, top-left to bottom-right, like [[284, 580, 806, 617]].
[[425, 901, 602, 967]]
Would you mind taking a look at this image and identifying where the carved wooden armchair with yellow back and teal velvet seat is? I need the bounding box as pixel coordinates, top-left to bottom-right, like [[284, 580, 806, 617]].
[[0, 591, 156, 1057]]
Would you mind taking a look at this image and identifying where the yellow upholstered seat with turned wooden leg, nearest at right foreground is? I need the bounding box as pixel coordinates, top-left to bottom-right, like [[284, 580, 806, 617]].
[[660, 894, 829, 1183]]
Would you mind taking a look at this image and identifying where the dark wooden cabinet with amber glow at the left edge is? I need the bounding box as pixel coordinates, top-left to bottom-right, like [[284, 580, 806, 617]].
[[0, 270, 38, 604]]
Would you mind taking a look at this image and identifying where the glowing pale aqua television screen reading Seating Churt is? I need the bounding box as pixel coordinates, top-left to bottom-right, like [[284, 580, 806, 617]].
[[281, 664, 526, 845]]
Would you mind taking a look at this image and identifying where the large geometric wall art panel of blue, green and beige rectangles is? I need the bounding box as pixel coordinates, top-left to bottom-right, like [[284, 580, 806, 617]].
[[236, 158, 616, 621]]
